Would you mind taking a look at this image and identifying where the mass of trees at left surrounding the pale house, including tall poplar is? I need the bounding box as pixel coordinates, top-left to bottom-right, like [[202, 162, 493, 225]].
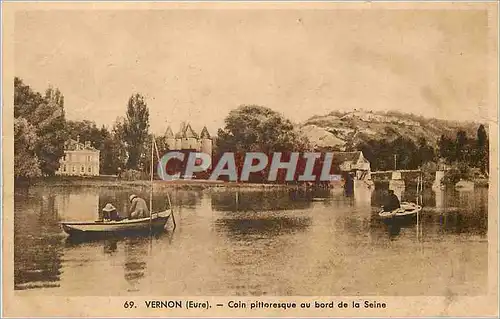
[[14, 77, 151, 178]]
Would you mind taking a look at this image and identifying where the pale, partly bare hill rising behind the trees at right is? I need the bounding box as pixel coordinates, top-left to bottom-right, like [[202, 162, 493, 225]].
[[300, 110, 481, 150]]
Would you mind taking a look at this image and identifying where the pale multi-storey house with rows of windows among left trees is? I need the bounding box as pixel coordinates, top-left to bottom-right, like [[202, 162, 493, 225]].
[[56, 137, 99, 176]]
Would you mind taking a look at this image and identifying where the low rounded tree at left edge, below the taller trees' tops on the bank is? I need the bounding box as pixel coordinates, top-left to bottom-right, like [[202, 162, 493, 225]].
[[14, 117, 42, 178]]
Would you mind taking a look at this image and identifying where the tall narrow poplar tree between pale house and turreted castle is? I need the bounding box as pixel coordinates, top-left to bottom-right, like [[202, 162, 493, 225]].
[[123, 94, 149, 169]]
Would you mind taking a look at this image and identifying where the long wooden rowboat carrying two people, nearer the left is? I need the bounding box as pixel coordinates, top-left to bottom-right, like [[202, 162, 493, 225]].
[[60, 211, 171, 235]]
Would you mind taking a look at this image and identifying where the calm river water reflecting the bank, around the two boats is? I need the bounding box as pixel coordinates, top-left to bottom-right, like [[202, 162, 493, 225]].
[[14, 186, 488, 296]]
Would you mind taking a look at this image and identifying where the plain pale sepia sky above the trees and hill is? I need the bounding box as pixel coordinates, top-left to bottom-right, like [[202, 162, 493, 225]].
[[14, 9, 492, 133]]
